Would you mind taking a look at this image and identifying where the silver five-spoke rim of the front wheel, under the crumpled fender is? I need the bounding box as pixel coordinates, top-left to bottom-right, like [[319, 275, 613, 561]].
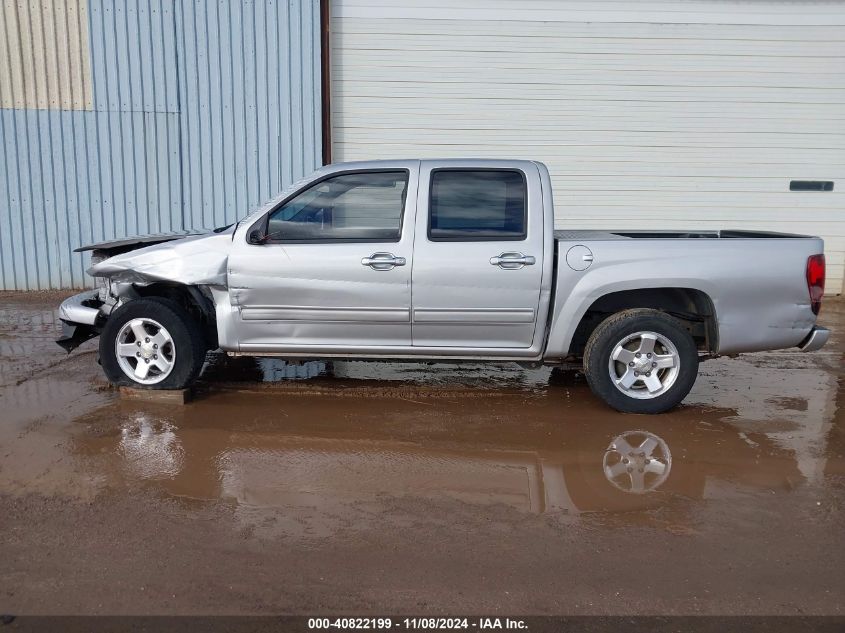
[[115, 319, 176, 385]]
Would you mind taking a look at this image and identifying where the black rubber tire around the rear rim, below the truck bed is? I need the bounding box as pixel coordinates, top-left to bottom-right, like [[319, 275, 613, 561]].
[[584, 308, 698, 413]]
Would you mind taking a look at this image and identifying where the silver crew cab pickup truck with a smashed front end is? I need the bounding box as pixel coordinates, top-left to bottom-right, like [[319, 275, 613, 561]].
[[59, 160, 829, 413]]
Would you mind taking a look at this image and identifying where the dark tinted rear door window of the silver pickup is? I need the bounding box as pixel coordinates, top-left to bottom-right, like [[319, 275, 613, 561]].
[[428, 169, 528, 242]]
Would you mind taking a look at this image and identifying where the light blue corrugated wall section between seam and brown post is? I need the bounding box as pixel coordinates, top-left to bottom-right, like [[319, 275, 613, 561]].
[[176, 0, 321, 232]]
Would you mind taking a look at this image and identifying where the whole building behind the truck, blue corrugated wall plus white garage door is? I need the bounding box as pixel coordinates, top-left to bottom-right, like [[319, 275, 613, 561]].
[[0, 0, 845, 293]]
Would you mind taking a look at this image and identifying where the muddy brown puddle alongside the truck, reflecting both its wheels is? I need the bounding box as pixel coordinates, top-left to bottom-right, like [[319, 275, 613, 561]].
[[71, 368, 824, 536]]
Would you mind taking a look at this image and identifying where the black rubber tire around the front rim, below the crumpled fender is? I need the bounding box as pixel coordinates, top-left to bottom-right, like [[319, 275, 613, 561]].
[[100, 297, 206, 389]]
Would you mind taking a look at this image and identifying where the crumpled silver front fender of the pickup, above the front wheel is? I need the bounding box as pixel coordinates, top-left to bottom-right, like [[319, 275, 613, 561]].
[[88, 227, 235, 286]]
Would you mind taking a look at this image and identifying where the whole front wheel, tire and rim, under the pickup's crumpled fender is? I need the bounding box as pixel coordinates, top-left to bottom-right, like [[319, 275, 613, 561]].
[[100, 297, 206, 389]]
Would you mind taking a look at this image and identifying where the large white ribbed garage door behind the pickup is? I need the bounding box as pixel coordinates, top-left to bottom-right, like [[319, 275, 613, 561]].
[[330, 0, 845, 293]]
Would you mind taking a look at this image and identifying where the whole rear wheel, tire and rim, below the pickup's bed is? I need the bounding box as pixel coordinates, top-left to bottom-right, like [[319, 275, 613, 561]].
[[584, 309, 698, 413]]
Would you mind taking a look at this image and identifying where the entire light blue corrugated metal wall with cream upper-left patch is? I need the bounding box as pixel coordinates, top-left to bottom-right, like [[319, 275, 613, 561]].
[[0, 0, 321, 289]]
